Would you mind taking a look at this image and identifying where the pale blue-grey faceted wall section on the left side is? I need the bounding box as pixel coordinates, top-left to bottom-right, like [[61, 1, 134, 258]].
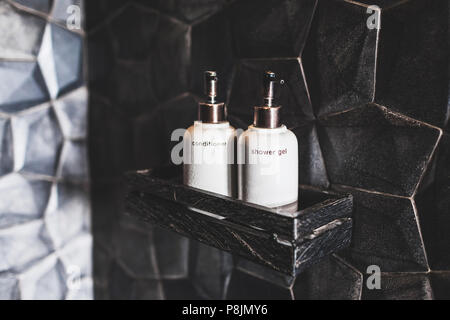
[[0, 0, 93, 299]]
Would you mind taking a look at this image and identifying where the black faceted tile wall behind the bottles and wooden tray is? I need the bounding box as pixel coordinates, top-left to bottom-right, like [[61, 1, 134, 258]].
[[85, 0, 450, 299]]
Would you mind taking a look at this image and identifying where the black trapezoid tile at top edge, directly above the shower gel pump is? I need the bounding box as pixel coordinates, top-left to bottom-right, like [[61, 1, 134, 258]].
[[228, 0, 317, 58]]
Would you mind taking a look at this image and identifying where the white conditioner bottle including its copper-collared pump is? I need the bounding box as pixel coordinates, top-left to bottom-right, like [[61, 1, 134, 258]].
[[183, 71, 236, 197]]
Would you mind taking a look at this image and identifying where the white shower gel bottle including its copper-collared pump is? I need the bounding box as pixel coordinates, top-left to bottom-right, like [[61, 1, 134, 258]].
[[238, 71, 298, 211]]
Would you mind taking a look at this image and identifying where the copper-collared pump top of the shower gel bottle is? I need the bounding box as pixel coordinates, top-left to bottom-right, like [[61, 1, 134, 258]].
[[253, 71, 280, 129]]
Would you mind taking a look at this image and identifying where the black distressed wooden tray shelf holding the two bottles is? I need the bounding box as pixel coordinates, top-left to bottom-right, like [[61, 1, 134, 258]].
[[124, 168, 353, 276]]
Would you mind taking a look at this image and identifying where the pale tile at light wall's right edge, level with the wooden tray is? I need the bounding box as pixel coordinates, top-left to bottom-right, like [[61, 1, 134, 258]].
[[45, 183, 90, 248]]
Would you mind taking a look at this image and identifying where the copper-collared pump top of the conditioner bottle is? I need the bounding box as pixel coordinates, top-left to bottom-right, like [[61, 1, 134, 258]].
[[198, 71, 225, 123]]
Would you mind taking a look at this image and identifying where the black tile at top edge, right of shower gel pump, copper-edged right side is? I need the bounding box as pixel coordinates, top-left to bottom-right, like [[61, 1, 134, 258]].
[[302, 0, 377, 115]]
